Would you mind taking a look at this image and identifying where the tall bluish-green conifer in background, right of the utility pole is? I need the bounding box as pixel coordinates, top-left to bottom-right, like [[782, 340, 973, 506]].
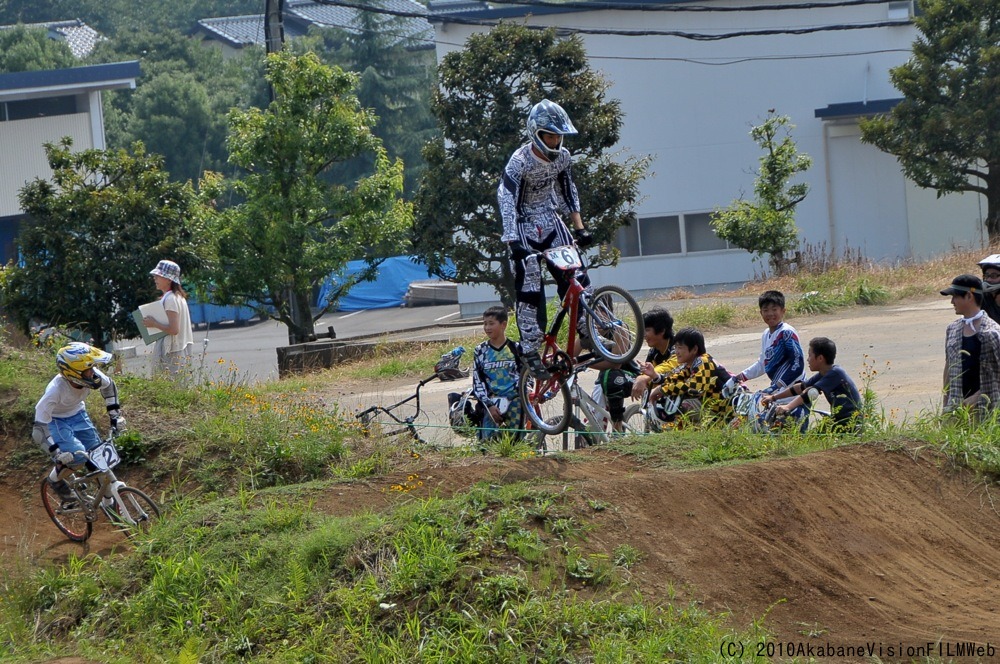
[[304, 0, 437, 197]]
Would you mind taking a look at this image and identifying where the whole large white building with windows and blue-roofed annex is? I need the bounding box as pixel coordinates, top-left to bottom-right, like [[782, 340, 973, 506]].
[[428, 0, 986, 315]]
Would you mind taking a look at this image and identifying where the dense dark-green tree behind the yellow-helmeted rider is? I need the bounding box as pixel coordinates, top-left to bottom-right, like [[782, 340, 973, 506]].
[[2, 138, 216, 345]]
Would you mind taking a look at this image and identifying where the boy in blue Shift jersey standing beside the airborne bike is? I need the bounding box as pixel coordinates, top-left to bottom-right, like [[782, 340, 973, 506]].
[[472, 306, 522, 440]]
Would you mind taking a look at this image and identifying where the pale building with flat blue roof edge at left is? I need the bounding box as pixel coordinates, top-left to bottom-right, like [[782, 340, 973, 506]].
[[0, 61, 140, 263]]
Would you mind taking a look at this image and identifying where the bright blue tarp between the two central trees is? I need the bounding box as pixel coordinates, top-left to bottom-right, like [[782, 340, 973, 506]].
[[317, 256, 452, 311]]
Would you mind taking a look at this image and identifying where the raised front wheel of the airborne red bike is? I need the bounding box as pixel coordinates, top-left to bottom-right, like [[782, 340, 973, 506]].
[[587, 286, 643, 364]]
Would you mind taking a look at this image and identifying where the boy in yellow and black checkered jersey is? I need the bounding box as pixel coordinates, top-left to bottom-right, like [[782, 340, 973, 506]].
[[643, 327, 735, 422]]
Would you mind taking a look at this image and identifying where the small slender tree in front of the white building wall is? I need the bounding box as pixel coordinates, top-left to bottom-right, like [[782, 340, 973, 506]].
[[712, 109, 812, 275]]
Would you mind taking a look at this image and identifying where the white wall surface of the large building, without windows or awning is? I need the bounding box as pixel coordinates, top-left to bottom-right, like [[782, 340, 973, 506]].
[[438, 2, 982, 312]]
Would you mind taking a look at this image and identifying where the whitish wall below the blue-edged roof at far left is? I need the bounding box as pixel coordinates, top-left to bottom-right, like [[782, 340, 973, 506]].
[[0, 113, 94, 217]]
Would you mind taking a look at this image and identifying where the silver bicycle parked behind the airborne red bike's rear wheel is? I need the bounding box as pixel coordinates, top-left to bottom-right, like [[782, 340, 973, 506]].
[[531, 360, 642, 454]]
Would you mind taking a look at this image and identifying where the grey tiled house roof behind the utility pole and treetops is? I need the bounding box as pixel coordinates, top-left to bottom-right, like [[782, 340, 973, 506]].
[[195, 0, 434, 57]]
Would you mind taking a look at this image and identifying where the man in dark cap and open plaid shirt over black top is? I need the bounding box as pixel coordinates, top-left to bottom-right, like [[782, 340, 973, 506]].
[[941, 274, 1000, 419]]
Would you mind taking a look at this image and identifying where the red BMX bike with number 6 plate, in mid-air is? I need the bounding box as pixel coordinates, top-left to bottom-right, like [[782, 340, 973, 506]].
[[519, 245, 643, 436]]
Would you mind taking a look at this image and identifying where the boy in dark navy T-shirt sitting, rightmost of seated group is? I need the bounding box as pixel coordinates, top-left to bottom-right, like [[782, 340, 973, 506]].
[[761, 337, 861, 432]]
